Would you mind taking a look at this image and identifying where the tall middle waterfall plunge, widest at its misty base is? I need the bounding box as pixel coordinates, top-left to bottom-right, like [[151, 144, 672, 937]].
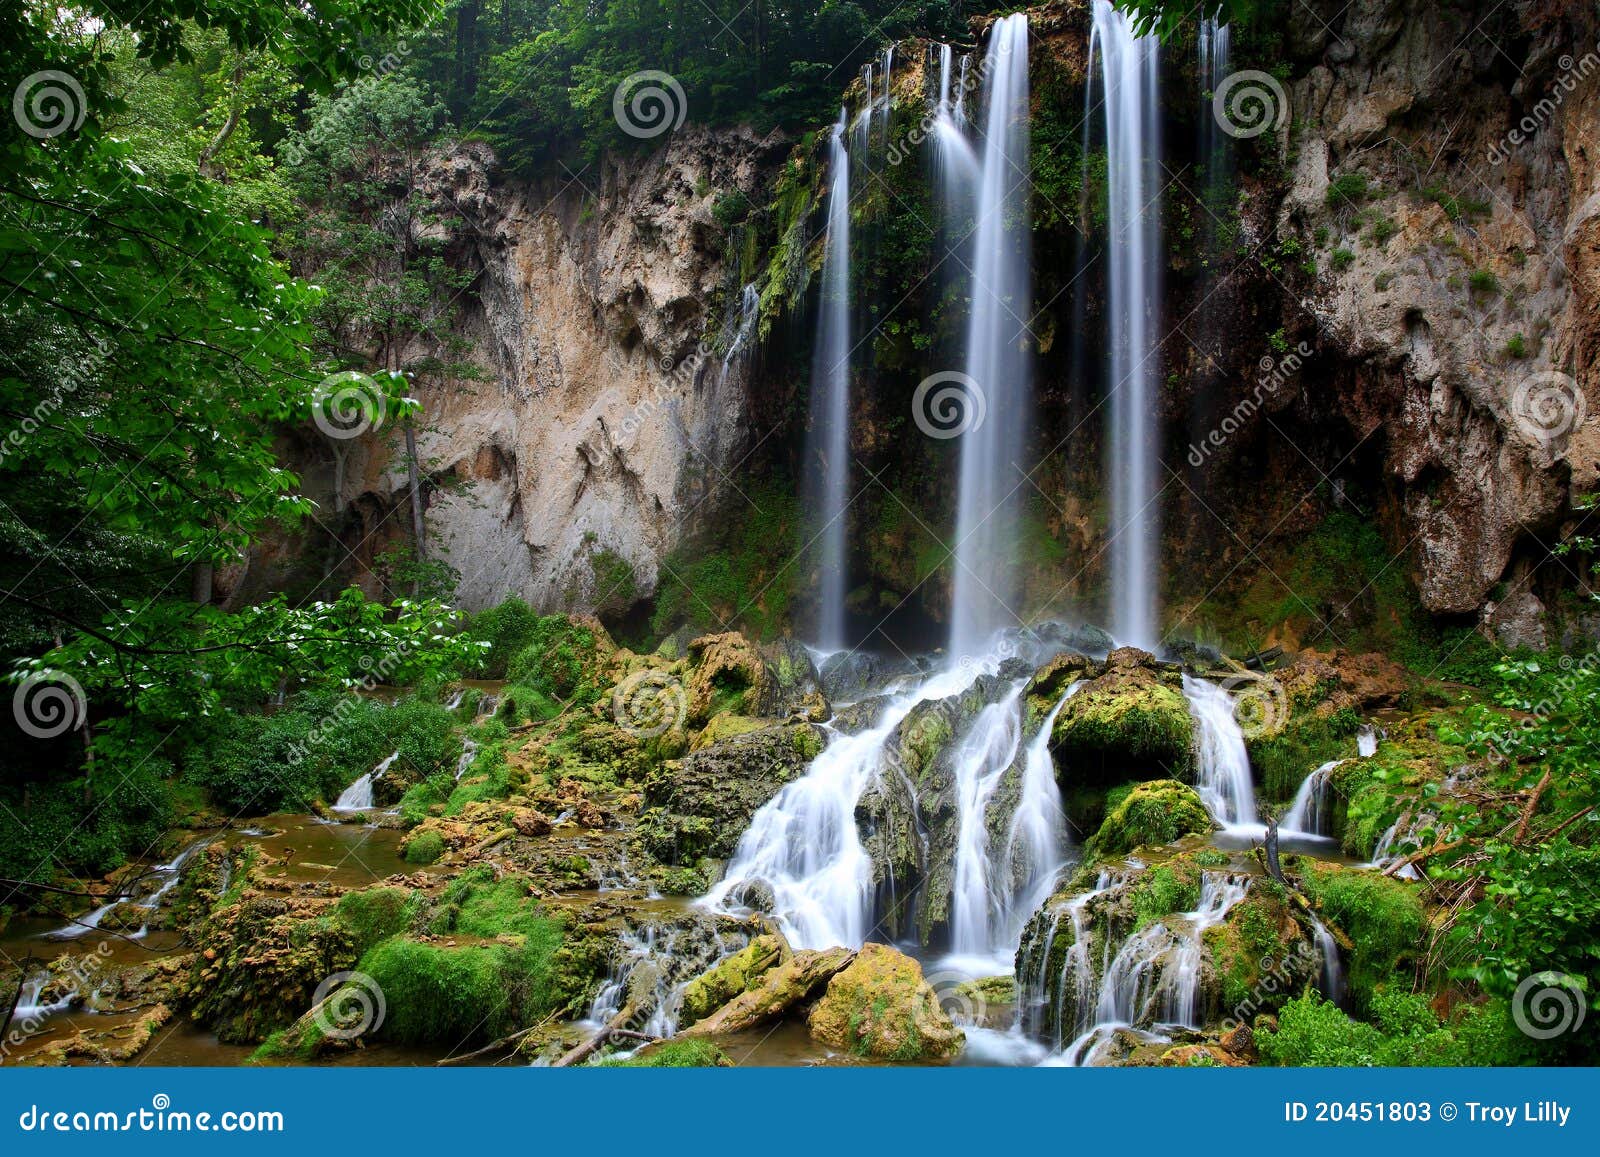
[[950, 13, 1034, 655]]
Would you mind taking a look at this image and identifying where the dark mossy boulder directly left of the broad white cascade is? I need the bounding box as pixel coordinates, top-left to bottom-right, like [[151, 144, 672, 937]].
[[634, 723, 826, 866]]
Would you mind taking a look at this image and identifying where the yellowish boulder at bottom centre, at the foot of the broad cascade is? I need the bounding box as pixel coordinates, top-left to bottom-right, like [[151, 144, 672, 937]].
[[806, 944, 966, 1061]]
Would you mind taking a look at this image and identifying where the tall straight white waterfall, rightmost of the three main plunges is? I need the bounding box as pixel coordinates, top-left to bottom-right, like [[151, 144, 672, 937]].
[[1090, 0, 1162, 648]]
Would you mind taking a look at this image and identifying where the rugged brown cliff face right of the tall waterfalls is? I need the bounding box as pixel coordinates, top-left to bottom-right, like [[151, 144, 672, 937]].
[[1278, 0, 1600, 645]]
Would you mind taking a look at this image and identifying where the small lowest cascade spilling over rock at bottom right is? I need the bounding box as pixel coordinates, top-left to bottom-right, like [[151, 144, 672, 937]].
[[1061, 872, 1250, 1064]]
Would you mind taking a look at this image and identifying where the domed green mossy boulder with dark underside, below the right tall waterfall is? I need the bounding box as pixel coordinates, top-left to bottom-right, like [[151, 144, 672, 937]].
[[1050, 647, 1195, 783]]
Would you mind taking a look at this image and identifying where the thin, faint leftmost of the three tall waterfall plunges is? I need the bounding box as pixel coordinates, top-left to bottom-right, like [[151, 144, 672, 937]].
[[810, 108, 872, 651]]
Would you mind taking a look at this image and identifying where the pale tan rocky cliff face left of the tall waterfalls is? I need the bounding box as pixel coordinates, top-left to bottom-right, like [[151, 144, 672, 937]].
[[296, 128, 787, 610]]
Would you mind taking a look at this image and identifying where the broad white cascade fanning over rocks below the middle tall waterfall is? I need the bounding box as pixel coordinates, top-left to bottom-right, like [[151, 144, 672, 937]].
[[701, 639, 1067, 953]]
